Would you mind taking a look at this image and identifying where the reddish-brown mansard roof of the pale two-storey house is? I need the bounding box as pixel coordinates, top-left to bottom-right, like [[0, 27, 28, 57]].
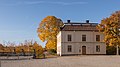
[[61, 23, 98, 31]]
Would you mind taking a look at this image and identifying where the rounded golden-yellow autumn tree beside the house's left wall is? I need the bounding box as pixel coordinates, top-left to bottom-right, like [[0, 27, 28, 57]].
[[37, 16, 63, 50]]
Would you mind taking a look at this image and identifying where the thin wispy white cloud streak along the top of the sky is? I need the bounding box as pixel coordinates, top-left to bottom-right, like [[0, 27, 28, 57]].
[[0, 1, 88, 6]]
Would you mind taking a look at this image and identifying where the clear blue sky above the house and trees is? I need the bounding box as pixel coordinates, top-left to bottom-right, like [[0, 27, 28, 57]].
[[0, 0, 120, 46]]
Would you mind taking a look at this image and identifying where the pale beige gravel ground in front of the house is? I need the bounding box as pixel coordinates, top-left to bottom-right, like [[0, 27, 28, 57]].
[[1, 56, 120, 67]]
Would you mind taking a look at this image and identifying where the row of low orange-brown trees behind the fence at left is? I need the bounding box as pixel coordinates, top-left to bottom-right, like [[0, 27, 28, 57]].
[[0, 40, 43, 54]]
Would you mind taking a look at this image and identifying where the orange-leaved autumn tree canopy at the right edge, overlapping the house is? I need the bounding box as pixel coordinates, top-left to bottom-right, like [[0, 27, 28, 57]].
[[98, 11, 120, 54]]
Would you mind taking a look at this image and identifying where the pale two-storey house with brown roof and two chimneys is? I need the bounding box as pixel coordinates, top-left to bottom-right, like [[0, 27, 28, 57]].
[[57, 20, 106, 56]]
